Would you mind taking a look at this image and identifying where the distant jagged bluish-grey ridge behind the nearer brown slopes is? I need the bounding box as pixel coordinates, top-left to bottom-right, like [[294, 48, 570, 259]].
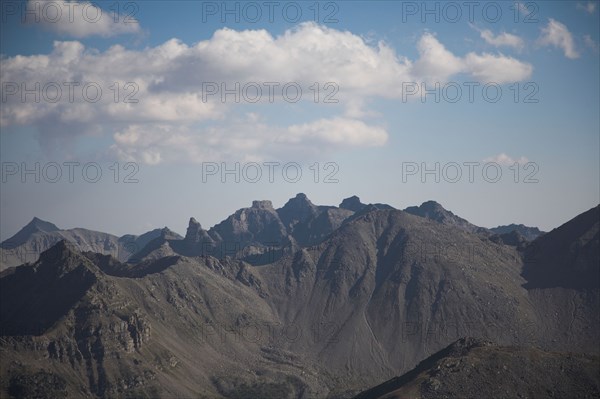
[[0, 193, 543, 270]]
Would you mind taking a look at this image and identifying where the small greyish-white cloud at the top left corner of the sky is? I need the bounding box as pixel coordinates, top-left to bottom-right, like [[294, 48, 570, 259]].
[[22, 0, 141, 38]]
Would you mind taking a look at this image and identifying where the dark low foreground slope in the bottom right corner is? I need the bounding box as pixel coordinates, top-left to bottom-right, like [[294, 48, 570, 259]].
[[355, 338, 600, 399]]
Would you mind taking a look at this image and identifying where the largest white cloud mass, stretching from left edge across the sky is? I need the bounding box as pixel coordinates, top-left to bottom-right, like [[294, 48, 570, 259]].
[[0, 23, 532, 163]]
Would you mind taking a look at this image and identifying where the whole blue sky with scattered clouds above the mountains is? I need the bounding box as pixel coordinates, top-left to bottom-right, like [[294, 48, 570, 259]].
[[0, 0, 600, 239]]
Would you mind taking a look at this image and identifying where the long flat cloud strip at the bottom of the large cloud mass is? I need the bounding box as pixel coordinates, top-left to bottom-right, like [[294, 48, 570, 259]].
[[111, 117, 388, 164]]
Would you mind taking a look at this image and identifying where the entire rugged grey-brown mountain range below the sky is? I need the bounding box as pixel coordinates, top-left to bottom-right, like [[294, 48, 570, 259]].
[[0, 194, 600, 398]]
